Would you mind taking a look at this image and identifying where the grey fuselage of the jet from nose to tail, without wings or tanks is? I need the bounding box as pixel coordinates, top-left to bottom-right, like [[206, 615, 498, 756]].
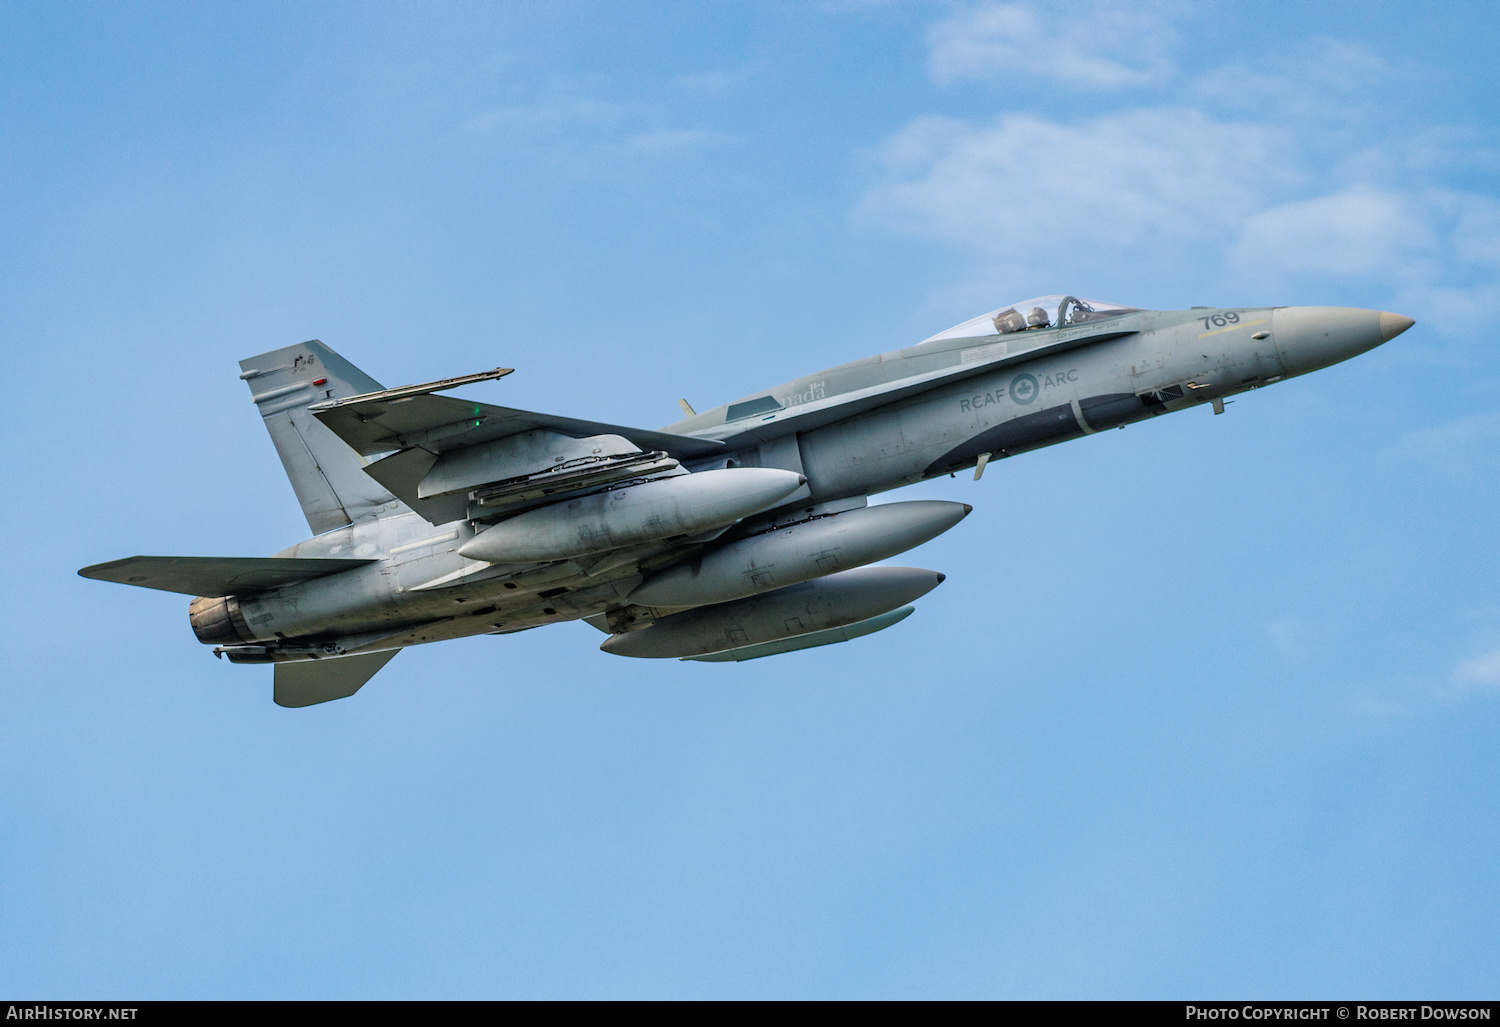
[[219, 299, 1412, 655]]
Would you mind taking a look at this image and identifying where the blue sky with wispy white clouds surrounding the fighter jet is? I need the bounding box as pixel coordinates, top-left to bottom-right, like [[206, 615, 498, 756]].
[[0, 3, 1500, 999]]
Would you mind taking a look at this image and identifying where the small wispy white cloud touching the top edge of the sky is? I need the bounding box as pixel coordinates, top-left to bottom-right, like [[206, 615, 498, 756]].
[[927, 4, 1173, 88]]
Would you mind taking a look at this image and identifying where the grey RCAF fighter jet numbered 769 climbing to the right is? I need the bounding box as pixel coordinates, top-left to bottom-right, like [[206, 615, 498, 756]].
[[78, 295, 1413, 706]]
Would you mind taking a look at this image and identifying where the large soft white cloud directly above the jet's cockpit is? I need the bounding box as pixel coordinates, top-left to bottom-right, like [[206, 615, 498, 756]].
[[860, 109, 1296, 275]]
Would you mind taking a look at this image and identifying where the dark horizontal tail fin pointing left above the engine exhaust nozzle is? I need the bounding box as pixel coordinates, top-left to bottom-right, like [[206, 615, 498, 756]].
[[78, 556, 375, 596]]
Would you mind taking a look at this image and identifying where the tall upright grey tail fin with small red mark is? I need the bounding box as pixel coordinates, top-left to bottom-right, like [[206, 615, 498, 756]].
[[240, 339, 395, 535]]
